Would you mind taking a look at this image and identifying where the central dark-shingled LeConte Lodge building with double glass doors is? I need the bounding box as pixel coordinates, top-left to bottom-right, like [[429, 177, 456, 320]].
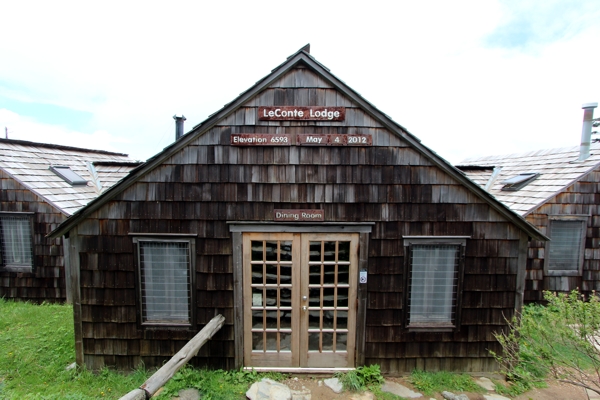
[[51, 47, 546, 374]]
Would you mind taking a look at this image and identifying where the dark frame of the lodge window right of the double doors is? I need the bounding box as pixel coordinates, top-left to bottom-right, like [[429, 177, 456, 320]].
[[403, 236, 470, 332]]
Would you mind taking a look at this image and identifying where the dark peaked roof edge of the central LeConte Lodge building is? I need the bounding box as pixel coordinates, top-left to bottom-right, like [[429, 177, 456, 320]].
[[49, 46, 547, 240]]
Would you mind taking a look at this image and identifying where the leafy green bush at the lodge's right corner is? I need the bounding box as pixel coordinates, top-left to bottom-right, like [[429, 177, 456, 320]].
[[492, 291, 600, 395]]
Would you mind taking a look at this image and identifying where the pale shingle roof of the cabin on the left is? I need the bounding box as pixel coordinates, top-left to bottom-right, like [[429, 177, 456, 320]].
[[0, 139, 140, 216]]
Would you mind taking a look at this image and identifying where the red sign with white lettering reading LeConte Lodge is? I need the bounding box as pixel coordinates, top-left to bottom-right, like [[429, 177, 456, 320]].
[[258, 106, 346, 121]]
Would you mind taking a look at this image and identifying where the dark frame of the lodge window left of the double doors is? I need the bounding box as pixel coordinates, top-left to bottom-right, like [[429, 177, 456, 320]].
[[130, 233, 197, 330]]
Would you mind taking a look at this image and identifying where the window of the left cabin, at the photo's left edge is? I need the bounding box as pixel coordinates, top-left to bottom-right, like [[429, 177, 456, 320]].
[[0, 213, 33, 272]]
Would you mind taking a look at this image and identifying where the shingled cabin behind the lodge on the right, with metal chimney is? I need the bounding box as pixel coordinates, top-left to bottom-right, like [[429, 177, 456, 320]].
[[458, 103, 600, 302]]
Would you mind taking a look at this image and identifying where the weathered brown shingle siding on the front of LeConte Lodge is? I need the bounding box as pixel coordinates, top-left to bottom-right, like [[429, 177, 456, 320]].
[[78, 65, 522, 373]]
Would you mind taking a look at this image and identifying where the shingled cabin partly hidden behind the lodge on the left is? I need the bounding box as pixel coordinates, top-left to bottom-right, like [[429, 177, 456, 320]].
[[0, 139, 139, 303]]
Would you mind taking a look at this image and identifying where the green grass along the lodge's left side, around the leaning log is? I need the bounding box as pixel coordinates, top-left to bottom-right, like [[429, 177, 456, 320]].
[[0, 298, 284, 400]]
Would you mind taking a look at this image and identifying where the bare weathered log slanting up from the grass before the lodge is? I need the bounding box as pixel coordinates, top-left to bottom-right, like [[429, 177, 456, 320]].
[[120, 314, 225, 400]]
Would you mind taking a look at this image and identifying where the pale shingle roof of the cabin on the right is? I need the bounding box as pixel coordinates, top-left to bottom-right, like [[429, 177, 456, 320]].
[[457, 143, 600, 216]]
